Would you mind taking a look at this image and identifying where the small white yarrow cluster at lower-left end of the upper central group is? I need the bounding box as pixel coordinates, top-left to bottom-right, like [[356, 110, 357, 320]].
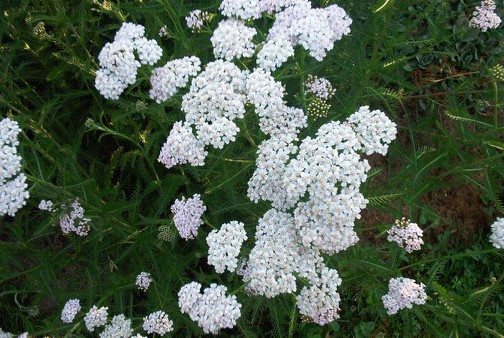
[[158, 121, 208, 169]]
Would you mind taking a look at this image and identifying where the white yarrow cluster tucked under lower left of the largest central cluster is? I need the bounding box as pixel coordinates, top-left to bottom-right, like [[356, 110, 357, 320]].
[[242, 209, 323, 298]]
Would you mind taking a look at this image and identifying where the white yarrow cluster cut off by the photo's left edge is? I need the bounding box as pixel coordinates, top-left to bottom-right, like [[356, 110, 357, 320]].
[[0, 117, 30, 217]]
